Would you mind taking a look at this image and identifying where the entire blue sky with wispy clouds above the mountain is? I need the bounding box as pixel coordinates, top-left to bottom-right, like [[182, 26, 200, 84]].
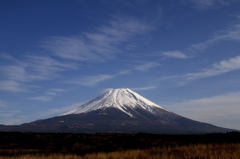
[[0, 0, 240, 129]]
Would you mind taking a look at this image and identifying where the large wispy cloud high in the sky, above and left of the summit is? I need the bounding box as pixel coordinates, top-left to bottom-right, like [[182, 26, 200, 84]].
[[42, 16, 153, 61]]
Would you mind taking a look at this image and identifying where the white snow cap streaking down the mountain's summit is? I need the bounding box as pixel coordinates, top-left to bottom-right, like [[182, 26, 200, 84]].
[[61, 88, 165, 117]]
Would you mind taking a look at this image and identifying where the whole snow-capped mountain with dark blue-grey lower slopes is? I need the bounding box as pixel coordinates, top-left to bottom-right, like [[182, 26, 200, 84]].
[[0, 89, 234, 134]]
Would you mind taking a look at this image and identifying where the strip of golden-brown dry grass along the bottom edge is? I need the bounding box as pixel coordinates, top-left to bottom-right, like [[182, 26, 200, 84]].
[[0, 144, 240, 159]]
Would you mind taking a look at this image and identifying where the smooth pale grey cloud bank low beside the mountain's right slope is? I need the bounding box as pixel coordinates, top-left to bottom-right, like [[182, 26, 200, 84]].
[[165, 92, 240, 129]]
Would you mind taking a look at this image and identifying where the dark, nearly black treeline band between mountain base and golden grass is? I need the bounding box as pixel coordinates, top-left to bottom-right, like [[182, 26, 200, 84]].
[[0, 132, 240, 155]]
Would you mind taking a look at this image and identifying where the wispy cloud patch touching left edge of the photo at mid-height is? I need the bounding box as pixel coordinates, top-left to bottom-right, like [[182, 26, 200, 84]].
[[0, 54, 78, 92]]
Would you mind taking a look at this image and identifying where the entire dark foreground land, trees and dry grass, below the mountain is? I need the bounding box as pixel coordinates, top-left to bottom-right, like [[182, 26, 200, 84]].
[[0, 132, 240, 159]]
